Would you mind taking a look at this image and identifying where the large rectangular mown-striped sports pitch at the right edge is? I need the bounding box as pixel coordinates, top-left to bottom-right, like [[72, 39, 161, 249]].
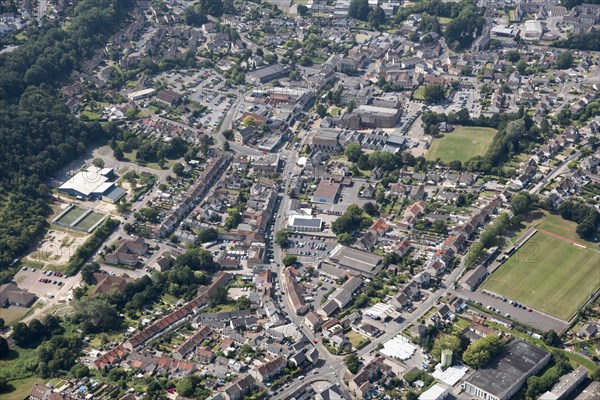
[[483, 232, 600, 321]]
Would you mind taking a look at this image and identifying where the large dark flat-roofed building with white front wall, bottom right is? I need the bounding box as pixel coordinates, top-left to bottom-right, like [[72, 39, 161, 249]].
[[463, 340, 550, 400]]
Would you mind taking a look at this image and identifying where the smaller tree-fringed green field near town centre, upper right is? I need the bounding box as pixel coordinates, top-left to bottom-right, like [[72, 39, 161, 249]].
[[427, 126, 497, 162]]
